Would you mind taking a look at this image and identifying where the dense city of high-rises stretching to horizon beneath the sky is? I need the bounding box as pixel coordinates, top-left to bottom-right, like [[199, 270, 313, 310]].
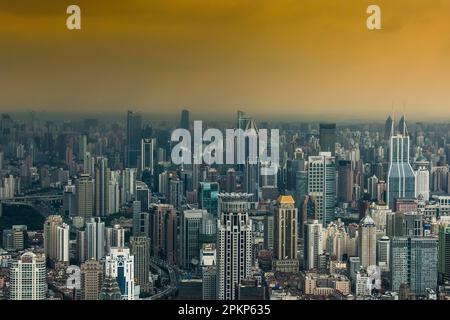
[[0, 110, 450, 300]]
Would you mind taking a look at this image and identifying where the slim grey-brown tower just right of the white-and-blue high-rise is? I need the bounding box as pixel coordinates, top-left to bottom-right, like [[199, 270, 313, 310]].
[[130, 236, 150, 292]]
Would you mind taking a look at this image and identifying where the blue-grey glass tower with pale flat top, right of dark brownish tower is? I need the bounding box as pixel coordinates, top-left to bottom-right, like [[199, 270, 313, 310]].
[[180, 209, 205, 269]]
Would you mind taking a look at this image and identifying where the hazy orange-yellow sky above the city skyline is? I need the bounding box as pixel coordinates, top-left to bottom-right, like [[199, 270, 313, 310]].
[[0, 0, 450, 121]]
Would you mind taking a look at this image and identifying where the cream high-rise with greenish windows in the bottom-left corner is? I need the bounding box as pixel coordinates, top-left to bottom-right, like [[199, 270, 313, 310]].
[[9, 252, 47, 300]]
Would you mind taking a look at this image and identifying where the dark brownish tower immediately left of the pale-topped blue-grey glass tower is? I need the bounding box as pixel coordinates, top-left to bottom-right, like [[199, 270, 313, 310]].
[[150, 204, 177, 264]]
